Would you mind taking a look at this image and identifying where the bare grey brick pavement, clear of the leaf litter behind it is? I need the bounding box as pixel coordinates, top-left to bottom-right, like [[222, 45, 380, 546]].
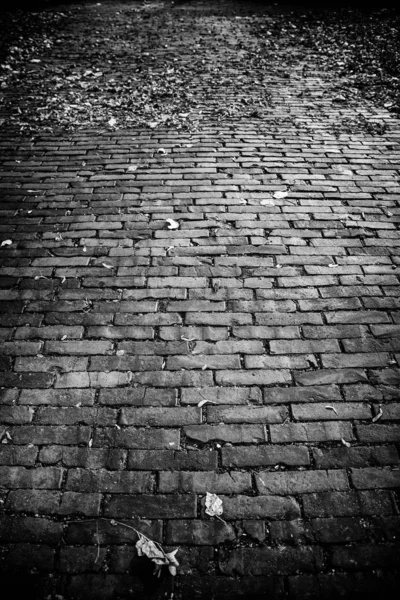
[[0, 3, 400, 600]]
